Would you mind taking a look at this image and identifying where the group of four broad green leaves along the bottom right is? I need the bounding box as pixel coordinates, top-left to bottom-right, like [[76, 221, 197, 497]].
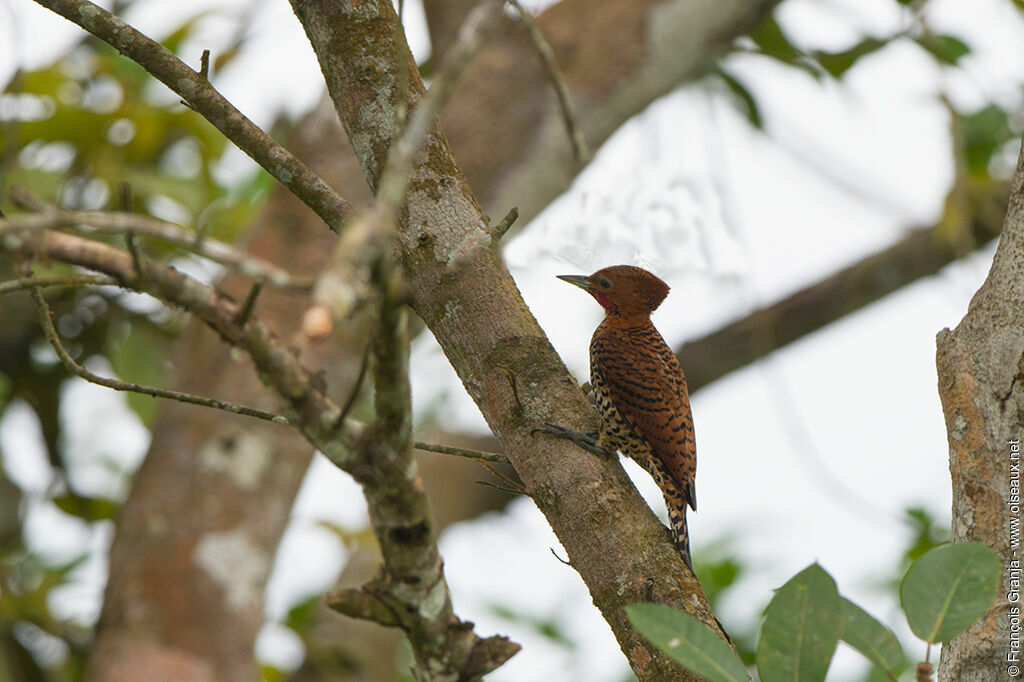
[[627, 543, 1001, 682]]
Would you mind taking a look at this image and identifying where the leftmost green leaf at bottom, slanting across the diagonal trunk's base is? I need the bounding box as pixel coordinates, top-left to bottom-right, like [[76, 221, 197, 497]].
[[626, 604, 751, 682]]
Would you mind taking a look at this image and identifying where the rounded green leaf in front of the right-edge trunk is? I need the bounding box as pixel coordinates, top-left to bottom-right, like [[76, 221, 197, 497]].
[[900, 543, 1002, 644]]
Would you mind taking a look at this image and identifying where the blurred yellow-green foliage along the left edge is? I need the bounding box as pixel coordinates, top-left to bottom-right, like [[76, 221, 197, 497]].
[[0, 7, 271, 682]]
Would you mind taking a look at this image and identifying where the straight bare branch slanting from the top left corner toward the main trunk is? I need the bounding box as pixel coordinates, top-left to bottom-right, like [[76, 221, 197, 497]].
[[36, 0, 351, 232]]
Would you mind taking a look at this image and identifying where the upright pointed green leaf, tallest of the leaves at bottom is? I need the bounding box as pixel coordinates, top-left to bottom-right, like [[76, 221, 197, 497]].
[[758, 563, 843, 682]]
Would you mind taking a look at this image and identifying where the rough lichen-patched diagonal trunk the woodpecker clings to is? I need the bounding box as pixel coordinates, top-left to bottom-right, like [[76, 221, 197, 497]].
[[293, 0, 737, 680]]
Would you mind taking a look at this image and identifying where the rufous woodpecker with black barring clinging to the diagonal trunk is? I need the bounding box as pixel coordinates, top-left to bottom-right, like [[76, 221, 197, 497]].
[[539, 265, 697, 572]]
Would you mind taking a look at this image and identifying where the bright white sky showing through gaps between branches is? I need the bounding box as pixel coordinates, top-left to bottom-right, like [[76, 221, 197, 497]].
[[0, 0, 1024, 682]]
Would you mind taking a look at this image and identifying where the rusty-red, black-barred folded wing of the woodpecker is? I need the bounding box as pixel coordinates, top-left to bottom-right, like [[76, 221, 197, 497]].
[[591, 326, 697, 511]]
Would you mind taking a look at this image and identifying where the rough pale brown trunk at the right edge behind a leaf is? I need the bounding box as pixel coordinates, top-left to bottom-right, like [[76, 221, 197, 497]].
[[936, 140, 1024, 682]]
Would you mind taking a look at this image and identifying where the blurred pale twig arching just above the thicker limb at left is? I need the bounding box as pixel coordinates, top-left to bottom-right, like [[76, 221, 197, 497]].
[[0, 207, 312, 291]]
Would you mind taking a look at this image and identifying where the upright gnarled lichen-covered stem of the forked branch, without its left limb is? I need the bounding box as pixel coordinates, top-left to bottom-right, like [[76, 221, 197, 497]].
[[339, 260, 519, 680]]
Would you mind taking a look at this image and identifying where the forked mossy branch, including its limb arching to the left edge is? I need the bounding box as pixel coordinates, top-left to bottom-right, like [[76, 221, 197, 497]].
[[0, 223, 519, 679]]
